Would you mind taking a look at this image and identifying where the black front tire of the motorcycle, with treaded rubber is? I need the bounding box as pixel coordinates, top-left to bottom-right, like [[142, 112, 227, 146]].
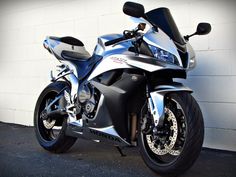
[[139, 92, 204, 176]]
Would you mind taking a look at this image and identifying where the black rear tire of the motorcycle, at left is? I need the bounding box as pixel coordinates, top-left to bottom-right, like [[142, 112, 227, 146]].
[[34, 81, 77, 153]]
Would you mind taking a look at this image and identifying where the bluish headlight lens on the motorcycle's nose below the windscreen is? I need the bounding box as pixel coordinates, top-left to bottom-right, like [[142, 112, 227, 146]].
[[149, 45, 180, 66]]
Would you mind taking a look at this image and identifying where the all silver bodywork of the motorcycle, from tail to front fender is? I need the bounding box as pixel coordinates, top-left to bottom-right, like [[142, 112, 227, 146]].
[[44, 13, 195, 145]]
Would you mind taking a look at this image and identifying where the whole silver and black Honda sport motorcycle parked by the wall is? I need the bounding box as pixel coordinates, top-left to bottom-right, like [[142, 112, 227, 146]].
[[34, 2, 211, 175]]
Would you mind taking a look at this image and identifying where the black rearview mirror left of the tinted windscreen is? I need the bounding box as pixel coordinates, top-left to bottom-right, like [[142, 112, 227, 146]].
[[123, 2, 145, 18]]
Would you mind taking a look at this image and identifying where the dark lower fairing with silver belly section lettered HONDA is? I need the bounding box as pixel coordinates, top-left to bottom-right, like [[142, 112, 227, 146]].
[[64, 65, 186, 145]]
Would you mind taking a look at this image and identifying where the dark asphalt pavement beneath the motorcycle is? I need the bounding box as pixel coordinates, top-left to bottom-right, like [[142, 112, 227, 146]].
[[0, 123, 236, 177]]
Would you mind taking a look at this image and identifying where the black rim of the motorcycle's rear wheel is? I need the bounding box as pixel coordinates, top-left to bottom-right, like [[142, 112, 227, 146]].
[[37, 91, 63, 141]]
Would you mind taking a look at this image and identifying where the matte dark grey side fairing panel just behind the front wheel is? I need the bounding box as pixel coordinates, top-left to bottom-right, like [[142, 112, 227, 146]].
[[91, 73, 145, 142]]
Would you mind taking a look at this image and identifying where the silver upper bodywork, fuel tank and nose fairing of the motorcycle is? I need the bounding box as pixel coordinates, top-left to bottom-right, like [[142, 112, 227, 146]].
[[88, 23, 196, 80]]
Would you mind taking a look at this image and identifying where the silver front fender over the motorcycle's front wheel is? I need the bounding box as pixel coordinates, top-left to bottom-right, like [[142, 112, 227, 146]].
[[148, 82, 193, 126]]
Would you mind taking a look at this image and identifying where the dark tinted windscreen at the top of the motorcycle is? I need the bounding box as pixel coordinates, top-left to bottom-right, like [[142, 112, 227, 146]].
[[146, 8, 185, 45]]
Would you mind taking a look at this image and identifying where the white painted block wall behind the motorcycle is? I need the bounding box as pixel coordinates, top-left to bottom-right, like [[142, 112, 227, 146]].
[[0, 0, 236, 151]]
